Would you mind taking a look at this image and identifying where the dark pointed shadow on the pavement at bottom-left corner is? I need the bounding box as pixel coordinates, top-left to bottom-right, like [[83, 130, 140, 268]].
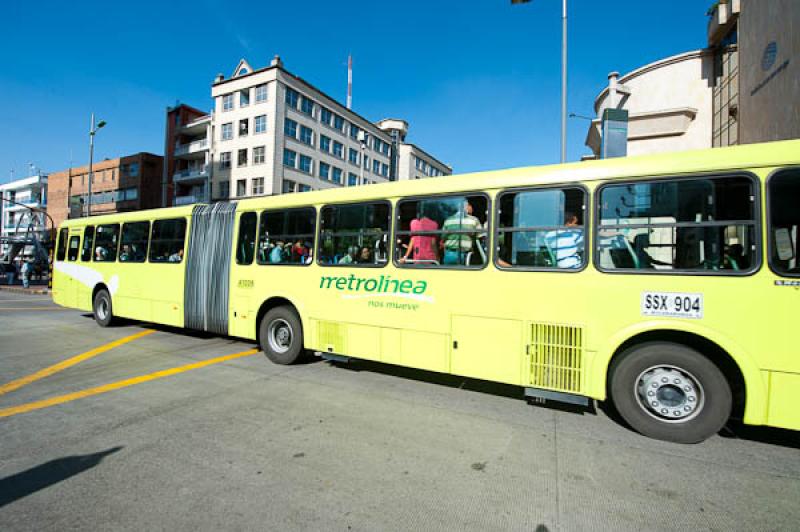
[[0, 447, 122, 508]]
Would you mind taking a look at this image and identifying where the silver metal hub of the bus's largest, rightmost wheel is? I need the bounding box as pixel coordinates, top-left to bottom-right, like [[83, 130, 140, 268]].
[[634, 366, 705, 423]]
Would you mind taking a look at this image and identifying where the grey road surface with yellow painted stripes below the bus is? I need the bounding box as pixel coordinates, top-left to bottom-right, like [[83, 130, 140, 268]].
[[0, 292, 800, 531]]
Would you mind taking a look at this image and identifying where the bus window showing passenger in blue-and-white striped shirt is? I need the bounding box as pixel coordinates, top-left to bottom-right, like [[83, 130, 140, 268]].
[[496, 187, 586, 270]]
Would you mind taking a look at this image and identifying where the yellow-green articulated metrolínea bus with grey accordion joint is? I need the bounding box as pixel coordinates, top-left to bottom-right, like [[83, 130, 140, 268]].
[[53, 141, 800, 443]]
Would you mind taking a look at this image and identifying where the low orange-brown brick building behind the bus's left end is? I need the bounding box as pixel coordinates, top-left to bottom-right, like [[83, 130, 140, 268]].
[[47, 153, 164, 225]]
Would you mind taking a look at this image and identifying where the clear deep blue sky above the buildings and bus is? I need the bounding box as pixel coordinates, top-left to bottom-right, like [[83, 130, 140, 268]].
[[0, 0, 711, 182]]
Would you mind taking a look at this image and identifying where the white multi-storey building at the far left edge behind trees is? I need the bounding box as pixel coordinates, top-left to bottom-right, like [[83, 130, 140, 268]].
[[0, 175, 49, 244]]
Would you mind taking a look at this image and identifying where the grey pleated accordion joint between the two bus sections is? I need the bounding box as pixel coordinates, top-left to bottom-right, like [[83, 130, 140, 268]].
[[183, 203, 236, 334]]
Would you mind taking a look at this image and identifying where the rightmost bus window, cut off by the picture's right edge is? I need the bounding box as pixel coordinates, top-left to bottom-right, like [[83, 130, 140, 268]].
[[767, 169, 800, 277]]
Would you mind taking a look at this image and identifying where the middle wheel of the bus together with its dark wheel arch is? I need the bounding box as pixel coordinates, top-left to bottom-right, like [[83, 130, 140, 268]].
[[256, 296, 308, 364]]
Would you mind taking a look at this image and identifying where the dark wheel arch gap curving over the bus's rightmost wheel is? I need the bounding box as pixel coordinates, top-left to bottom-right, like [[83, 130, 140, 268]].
[[605, 329, 747, 438]]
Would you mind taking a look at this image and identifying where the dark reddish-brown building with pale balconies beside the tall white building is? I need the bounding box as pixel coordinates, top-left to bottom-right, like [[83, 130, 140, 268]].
[[161, 104, 212, 205]]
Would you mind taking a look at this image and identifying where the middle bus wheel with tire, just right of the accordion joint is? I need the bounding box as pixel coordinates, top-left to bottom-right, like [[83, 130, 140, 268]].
[[258, 306, 303, 365]]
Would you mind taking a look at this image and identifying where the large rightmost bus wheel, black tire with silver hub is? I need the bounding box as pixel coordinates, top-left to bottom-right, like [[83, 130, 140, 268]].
[[610, 342, 733, 443]]
